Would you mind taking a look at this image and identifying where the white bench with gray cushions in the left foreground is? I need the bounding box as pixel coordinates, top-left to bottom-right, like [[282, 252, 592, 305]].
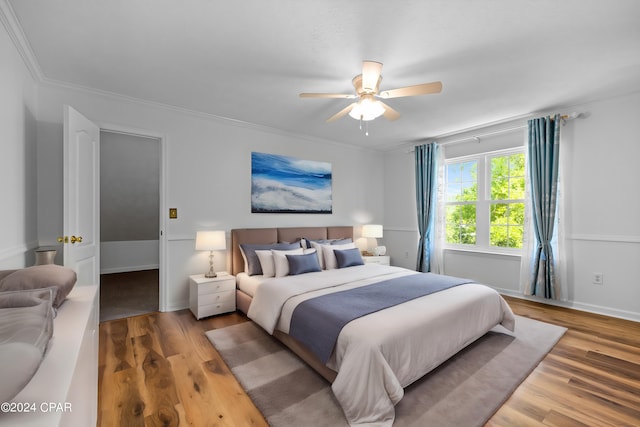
[[0, 265, 99, 427]]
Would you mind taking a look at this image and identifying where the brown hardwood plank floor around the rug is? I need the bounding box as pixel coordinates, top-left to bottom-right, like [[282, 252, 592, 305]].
[[98, 298, 640, 427]]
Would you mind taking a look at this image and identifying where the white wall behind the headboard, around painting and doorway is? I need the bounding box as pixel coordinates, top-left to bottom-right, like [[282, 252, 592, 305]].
[[38, 85, 384, 310]]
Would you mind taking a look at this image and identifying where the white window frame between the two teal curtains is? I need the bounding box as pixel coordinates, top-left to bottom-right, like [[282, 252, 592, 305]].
[[439, 146, 528, 256]]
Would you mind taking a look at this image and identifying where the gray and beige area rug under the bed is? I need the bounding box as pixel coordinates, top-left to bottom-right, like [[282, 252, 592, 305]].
[[206, 316, 566, 427]]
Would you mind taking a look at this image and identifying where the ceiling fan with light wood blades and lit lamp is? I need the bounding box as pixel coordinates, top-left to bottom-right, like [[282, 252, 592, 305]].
[[300, 61, 442, 123]]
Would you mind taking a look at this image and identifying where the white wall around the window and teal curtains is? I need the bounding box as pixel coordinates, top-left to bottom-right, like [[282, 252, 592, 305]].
[[384, 93, 640, 320]]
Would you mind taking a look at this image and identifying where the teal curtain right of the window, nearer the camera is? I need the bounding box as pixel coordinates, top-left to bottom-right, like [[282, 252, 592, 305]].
[[527, 115, 560, 299]]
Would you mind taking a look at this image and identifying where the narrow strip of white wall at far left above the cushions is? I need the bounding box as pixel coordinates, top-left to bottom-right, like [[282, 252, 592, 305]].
[[0, 18, 38, 269]]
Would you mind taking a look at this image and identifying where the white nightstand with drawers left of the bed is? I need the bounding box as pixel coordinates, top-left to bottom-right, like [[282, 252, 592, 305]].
[[189, 272, 236, 319]]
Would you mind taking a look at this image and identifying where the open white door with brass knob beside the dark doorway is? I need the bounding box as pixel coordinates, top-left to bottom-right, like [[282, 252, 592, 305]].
[[63, 105, 100, 286]]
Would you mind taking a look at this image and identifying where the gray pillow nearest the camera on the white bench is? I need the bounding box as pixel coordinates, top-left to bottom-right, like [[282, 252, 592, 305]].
[[0, 288, 55, 402]]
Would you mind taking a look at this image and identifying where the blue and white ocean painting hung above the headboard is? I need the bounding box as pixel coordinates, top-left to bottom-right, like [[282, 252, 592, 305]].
[[251, 152, 332, 214]]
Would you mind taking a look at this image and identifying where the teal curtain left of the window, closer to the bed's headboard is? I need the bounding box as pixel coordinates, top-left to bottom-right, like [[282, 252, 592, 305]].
[[415, 142, 439, 273]]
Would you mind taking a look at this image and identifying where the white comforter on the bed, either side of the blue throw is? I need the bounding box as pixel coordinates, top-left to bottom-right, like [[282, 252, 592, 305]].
[[248, 264, 515, 426]]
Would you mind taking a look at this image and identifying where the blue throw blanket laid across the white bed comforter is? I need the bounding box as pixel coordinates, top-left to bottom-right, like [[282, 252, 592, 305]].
[[289, 273, 473, 363]]
